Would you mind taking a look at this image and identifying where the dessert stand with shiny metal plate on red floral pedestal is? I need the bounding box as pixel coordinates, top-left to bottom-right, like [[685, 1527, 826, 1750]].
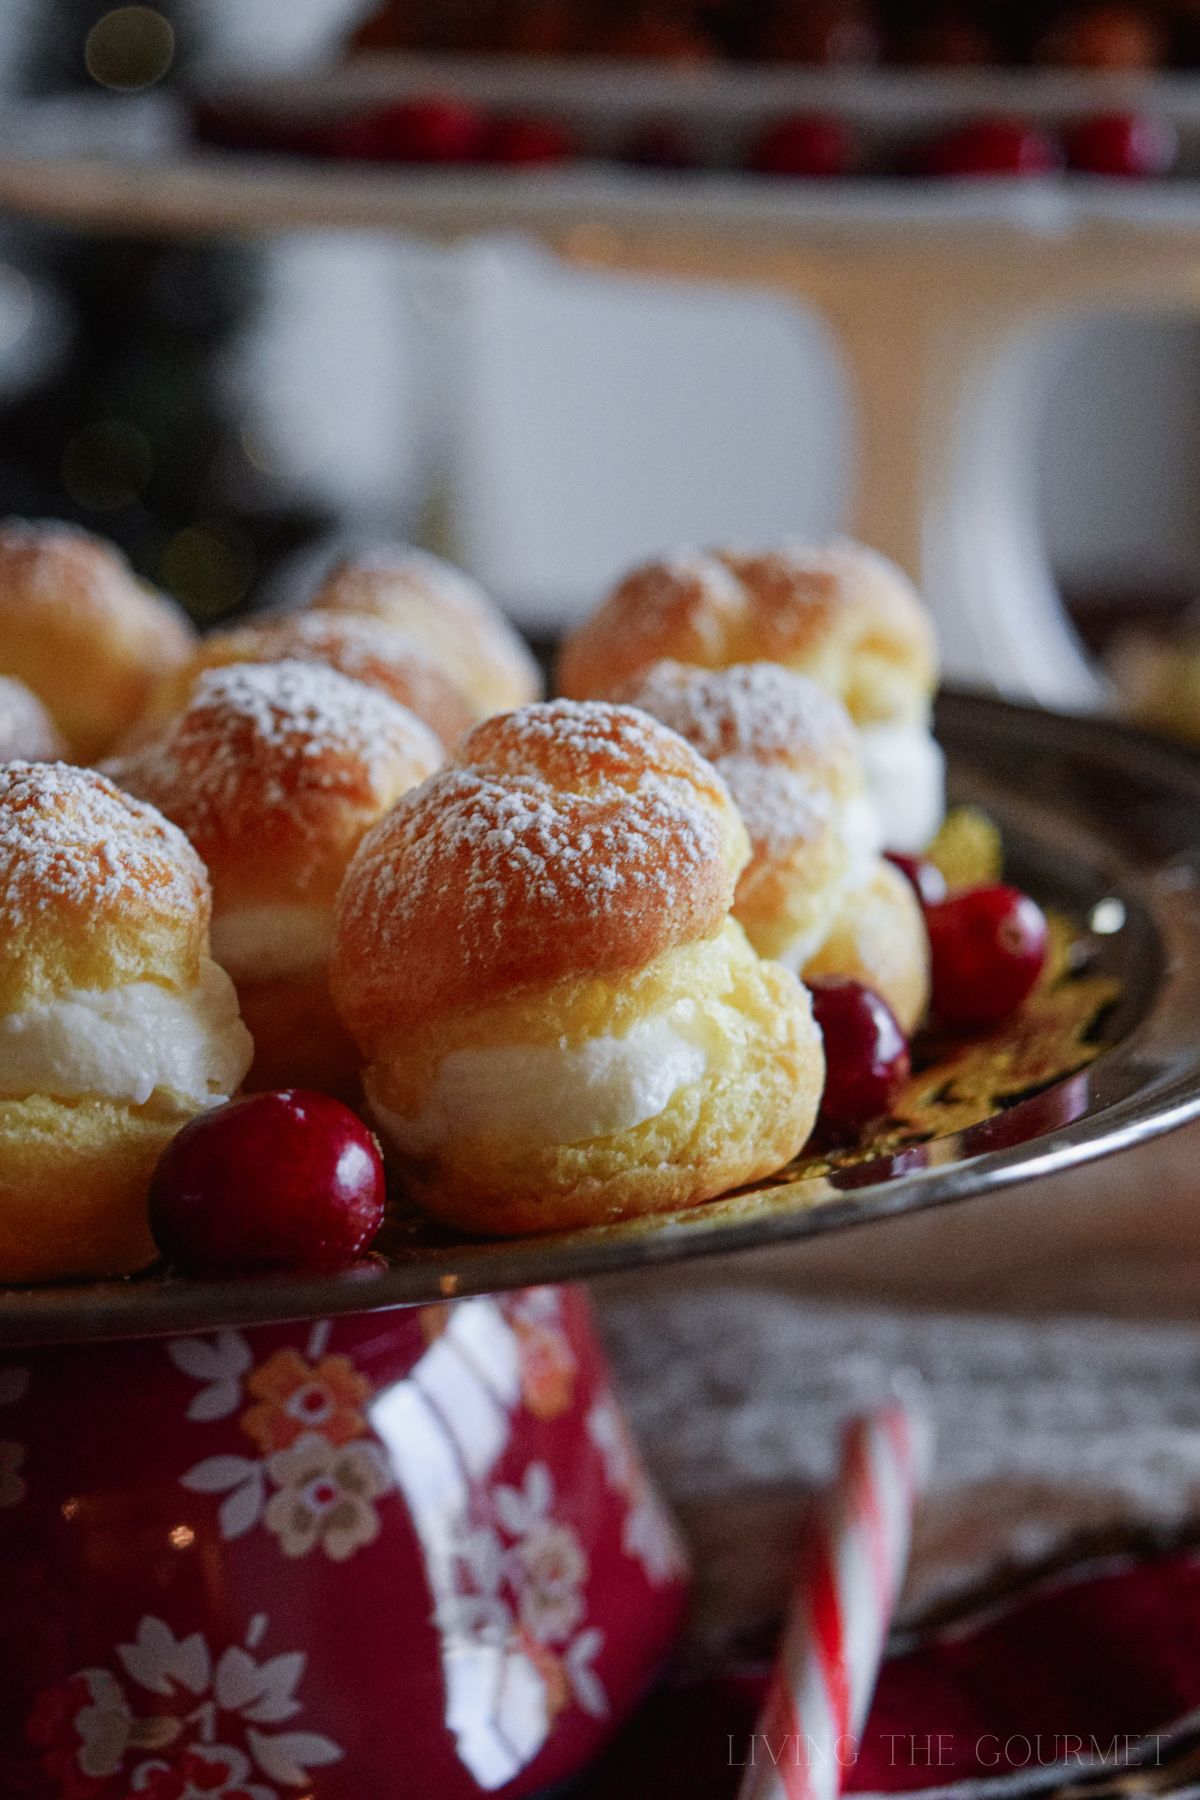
[[0, 695, 1200, 1800]]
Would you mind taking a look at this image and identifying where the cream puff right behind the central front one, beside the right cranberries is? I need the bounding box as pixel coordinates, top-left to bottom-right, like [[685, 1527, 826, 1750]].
[[622, 662, 928, 1031]]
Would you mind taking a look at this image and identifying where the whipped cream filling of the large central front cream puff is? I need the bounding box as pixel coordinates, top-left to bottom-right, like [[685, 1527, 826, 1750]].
[[365, 1001, 720, 1156]]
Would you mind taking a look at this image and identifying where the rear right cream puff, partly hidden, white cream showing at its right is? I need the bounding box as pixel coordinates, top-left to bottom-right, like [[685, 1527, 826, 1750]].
[[560, 540, 945, 851]]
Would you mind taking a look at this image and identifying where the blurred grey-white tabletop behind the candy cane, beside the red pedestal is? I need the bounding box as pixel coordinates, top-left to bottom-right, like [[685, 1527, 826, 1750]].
[[597, 1258, 1200, 1658]]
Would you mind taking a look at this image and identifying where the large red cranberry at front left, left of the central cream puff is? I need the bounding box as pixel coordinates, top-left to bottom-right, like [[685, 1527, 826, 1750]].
[[149, 1089, 383, 1274]]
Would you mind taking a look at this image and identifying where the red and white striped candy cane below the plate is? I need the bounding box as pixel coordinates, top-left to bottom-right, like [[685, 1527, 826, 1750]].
[[739, 1404, 932, 1800]]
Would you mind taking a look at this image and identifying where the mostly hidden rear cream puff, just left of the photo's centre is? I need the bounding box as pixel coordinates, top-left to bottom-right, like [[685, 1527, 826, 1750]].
[[309, 547, 542, 718]]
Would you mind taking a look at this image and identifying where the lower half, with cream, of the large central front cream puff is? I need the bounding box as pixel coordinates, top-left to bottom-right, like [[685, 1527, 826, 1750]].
[[365, 922, 824, 1237]]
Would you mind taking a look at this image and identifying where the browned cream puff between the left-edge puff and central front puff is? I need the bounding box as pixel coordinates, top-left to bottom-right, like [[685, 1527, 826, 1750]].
[[108, 662, 443, 1094]]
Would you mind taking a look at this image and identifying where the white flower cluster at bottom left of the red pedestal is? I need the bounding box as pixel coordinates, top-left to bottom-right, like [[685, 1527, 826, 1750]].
[[27, 1615, 342, 1800]]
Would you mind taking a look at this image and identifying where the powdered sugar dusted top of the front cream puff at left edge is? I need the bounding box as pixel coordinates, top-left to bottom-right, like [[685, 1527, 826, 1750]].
[[0, 761, 207, 929]]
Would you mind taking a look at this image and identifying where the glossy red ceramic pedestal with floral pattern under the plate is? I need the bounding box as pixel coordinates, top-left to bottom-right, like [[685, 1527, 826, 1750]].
[[0, 1289, 685, 1800]]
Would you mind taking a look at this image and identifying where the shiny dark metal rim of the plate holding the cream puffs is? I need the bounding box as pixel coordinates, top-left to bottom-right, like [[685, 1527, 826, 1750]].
[[0, 693, 1200, 1343]]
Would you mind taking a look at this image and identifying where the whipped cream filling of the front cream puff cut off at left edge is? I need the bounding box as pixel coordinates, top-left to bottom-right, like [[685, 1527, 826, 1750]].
[[0, 961, 254, 1112]]
